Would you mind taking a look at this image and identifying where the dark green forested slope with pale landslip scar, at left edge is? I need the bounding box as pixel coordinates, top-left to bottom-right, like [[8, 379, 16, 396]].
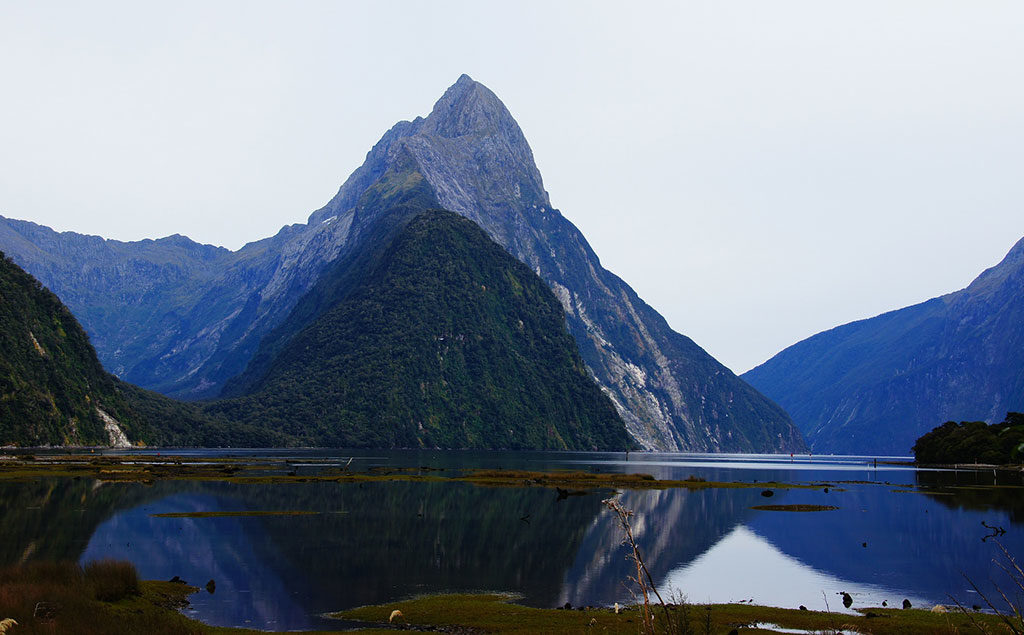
[[0, 248, 295, 447]]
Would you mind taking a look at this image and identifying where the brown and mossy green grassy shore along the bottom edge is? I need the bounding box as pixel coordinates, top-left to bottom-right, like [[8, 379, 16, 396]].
[[0, 561, 1008, 635]]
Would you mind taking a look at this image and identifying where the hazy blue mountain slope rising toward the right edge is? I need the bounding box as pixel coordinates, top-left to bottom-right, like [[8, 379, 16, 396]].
[[743, 235, 1024, 455]]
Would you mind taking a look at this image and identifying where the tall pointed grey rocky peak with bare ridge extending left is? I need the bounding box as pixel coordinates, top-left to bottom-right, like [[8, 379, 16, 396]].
[[0, 76, 804, 452]]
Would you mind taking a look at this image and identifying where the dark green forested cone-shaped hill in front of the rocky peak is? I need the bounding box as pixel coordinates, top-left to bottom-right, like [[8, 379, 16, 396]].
[[216, 210, 632, 450]]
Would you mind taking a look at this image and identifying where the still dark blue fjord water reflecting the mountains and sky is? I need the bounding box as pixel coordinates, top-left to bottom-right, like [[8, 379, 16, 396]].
[[0, 451, 1024, 630]]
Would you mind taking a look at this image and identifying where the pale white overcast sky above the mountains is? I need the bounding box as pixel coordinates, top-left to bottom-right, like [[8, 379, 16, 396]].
[[0, 0, 1024, 373]]
